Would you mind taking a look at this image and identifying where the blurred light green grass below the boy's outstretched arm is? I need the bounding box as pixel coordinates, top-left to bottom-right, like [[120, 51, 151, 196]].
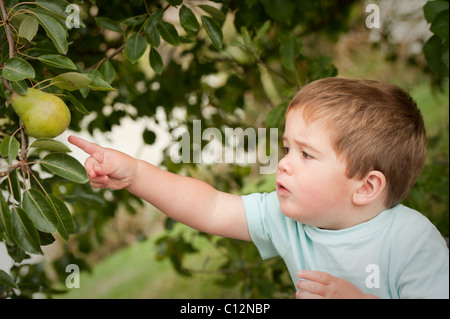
[[57, 226, 244, 299]]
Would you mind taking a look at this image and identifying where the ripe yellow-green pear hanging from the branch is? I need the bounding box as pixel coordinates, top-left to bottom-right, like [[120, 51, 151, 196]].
[[11, 88, 70, 138]]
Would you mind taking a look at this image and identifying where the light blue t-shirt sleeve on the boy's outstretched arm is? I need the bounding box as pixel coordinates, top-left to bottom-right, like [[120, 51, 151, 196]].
[[242, 192, 279, 259]]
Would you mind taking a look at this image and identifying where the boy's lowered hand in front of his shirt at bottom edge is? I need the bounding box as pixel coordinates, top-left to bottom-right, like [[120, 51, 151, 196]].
[[296, 270, 376, 299]]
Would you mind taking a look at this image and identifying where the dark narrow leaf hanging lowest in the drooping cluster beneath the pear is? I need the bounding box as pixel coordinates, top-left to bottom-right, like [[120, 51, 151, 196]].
[[11, 207, 43, 255]]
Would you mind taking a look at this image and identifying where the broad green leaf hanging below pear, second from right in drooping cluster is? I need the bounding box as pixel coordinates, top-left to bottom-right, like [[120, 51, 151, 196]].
[[23, 189, 58, 233]]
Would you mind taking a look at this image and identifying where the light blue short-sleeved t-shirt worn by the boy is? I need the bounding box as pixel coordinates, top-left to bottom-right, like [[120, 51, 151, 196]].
[[242, 192, 449, 299]]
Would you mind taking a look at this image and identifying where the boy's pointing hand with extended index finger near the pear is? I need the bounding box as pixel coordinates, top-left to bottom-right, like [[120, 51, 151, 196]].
[[69, 136, 138, 189]]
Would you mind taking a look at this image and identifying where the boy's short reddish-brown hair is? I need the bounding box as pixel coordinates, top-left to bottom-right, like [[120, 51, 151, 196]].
[[286, 77, 426, 208]]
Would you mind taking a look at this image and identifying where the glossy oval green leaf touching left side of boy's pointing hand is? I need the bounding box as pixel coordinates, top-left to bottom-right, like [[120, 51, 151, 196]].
[[40, 153, 88, 184]]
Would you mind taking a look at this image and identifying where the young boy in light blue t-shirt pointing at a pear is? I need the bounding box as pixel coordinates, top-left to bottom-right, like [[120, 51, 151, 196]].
[[69, 78, 449, 298]]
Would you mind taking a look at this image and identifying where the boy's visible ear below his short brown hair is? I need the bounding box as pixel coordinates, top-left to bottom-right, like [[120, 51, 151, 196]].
[[352, 171, 386, 205]]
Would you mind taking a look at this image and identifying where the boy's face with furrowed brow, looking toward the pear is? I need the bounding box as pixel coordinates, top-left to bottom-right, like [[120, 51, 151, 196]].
[[276, 109, 357, 229]]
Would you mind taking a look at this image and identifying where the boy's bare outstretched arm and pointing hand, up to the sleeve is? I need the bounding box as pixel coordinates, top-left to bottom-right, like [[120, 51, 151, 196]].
[[69, 136, 251, 241]]
